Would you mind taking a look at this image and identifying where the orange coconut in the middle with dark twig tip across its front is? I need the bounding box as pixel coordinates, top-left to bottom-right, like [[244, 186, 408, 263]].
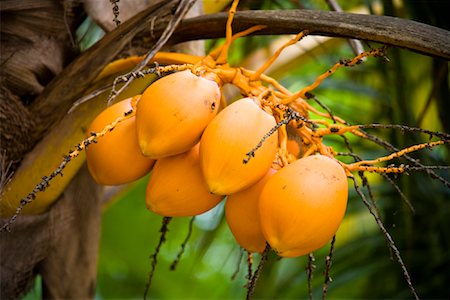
[[200, 98, 278, 195]]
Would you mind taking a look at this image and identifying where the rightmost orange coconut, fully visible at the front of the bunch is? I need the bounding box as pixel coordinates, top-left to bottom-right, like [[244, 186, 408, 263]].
[[259, 155, 348, 257]]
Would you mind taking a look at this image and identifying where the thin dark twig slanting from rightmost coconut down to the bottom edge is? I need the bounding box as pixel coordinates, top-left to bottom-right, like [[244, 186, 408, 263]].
[[352, 177, 419, 300]]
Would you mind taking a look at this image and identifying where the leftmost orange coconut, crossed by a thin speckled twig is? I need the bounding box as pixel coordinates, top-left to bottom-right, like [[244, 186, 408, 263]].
[[86, 96, 155, 185]]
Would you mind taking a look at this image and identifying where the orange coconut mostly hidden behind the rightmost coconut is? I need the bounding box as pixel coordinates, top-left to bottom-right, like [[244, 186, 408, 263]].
[[225, 169, 276, 253]]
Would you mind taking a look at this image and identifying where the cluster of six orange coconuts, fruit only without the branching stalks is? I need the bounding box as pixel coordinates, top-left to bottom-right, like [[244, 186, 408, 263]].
[[87, 63, 348, 257]]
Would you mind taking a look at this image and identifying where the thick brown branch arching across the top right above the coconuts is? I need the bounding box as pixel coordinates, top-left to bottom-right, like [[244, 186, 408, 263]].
[[170, 10, 450, 60]]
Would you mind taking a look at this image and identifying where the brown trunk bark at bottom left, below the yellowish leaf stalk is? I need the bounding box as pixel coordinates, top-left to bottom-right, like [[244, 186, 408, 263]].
[[0, 167, 101, 299]]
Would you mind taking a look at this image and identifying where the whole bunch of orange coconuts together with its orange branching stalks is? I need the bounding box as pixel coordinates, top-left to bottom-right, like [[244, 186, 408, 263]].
[[83, 0, 449, 257]]
